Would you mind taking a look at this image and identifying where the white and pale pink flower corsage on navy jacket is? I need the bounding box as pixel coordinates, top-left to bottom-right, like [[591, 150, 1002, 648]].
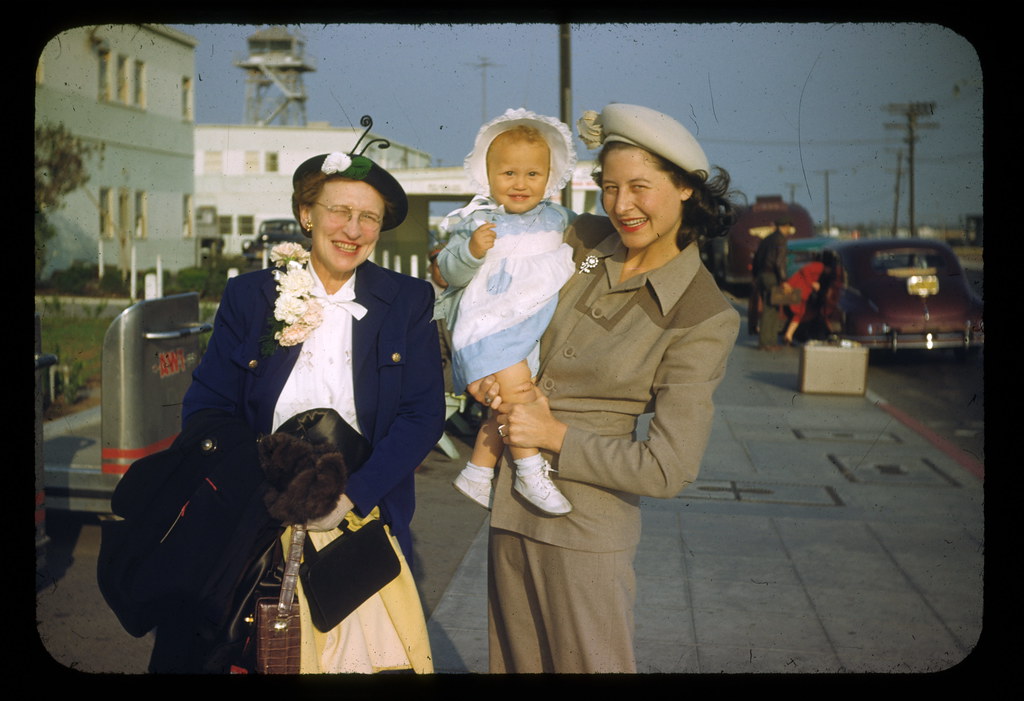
[[263, 244, 324, 355]]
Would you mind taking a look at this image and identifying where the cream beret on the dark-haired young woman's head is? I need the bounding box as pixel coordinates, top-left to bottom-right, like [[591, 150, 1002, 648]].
[[577, 102, 711, 175]]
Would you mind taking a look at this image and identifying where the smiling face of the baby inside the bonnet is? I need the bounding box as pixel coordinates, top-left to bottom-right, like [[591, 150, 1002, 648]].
[[487, 134, 551, 214]]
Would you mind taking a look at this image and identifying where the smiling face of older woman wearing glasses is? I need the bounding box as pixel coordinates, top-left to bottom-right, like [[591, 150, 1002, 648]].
[[301, 180, 384, 294]]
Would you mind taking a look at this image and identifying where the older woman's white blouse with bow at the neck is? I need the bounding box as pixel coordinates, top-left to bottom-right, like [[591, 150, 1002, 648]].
[[272, 265, 367, 433]]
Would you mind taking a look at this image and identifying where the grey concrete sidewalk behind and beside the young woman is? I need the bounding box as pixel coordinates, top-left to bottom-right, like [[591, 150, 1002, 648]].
[[428, 327, 985, 673]]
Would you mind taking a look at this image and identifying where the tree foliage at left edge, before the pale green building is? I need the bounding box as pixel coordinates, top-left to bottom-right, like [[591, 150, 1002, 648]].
[[35, 124, 97, 281]]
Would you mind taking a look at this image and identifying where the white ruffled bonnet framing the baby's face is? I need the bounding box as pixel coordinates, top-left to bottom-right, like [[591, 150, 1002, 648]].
[[463, 108, 577, 198]]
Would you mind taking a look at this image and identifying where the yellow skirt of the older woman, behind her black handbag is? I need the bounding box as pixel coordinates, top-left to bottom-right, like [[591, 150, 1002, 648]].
[[282, 509, 434, 674]]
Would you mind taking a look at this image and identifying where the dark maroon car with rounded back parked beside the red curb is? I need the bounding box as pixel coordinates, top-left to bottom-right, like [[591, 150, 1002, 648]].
[[822, 238, 985, 351]]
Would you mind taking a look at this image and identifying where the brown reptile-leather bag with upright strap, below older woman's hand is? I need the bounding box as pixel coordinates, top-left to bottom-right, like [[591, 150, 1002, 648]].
[[256, 525, 306, 674]]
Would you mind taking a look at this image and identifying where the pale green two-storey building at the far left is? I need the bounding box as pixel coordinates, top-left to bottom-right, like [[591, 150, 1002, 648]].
[[35, 25, 197, 276]]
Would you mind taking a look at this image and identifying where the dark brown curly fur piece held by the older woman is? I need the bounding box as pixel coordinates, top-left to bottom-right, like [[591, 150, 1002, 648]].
[[259, 433, 348, 523]]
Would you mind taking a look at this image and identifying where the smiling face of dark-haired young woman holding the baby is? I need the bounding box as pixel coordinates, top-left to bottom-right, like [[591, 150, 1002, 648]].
[[601, 146, 693, 254]]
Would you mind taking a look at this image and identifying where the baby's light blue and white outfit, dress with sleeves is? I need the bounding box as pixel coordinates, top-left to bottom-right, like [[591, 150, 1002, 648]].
[[434, 195, 575, 392]]
